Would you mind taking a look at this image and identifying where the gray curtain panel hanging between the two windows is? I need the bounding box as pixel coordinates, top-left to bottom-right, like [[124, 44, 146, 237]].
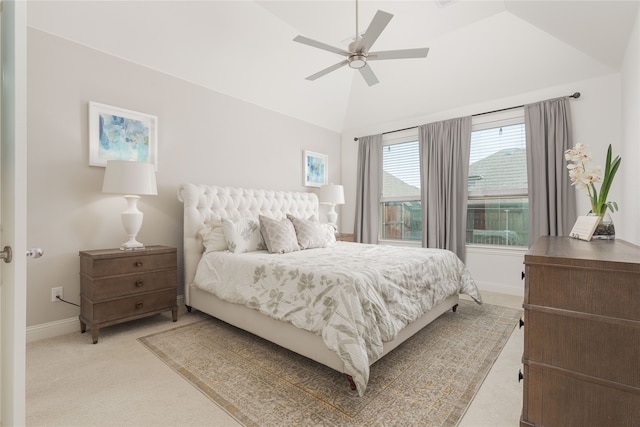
[[419, 117, 471, 262]]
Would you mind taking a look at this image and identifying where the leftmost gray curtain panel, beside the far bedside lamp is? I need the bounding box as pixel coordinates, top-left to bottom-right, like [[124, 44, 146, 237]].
[[353, 134, 382, 243]]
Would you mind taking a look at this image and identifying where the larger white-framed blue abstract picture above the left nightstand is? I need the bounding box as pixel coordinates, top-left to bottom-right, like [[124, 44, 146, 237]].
[[89, 102, 158, 172]]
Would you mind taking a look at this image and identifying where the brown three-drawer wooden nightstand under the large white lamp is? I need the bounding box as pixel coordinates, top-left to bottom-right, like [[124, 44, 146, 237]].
[[80, 246, 178, 344]]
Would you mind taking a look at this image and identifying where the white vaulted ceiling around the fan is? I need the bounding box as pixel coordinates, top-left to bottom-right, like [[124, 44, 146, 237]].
[[28, 0, 639, 132]]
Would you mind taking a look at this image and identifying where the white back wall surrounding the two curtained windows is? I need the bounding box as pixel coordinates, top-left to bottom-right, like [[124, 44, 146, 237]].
[[340, 73, 624, 295]]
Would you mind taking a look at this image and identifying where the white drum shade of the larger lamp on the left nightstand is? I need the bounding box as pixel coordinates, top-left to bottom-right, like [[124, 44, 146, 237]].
[[102, 160, 158, 195]]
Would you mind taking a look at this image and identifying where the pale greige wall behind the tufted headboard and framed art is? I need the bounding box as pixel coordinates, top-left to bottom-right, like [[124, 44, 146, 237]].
[[27, 29, 340, 332]]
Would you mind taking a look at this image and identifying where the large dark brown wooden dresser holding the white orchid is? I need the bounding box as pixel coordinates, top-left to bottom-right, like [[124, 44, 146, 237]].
[[520, 237, 640, 427]]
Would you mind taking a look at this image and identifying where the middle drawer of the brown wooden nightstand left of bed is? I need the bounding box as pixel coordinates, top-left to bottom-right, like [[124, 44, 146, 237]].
[[80, 269, 177, 302]]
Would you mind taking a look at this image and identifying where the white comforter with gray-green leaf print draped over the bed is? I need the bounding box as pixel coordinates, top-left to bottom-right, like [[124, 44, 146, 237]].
[[194, 242, 481, 396]]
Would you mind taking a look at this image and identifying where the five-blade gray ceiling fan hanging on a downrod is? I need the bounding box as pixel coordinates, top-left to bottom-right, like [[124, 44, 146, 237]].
[[293, 0, 429, 86]]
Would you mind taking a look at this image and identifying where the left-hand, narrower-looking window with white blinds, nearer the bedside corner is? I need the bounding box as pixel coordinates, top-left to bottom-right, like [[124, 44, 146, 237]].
[[380, 129, 422, 242]]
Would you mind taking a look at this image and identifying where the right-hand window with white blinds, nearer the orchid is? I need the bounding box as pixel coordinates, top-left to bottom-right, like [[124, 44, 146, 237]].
[[466, 109, 529, 246]]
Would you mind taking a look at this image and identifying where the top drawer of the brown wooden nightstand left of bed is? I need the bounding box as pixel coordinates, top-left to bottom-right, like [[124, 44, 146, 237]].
[[81, 253, 177, 278]]
